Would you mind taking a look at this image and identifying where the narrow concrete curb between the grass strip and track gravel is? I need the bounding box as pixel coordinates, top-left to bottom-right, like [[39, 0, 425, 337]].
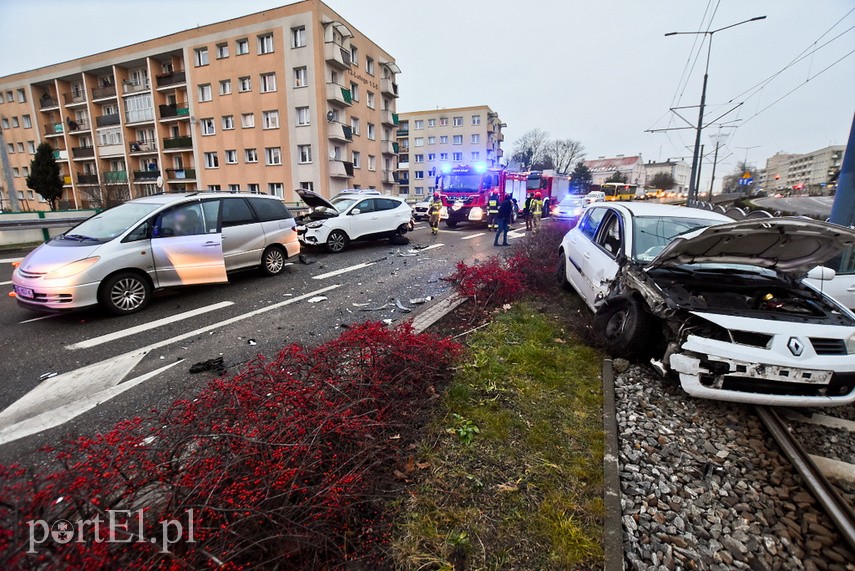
[[603, 359, 624, 571]]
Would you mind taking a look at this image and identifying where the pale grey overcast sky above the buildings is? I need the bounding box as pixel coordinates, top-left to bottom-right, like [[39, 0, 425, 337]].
[[0, 0, 855, 192]]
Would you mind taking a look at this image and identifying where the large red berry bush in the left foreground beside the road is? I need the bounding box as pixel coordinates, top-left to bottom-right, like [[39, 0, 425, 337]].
[[0, 323, 461, 569]]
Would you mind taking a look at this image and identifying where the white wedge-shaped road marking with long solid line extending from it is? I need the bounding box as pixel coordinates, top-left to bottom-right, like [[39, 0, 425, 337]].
[[0, 284, 341, 444]]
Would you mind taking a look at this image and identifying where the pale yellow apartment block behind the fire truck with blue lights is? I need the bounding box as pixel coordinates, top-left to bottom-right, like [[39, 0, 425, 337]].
[[396, 105, 507, 197]]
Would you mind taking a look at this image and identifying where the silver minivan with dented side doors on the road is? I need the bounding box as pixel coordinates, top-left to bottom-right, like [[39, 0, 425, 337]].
[[12, 192, 300, 315]]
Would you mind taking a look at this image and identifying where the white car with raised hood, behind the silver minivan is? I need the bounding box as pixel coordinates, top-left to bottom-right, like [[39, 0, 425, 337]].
[[297, 190, 412, 254]]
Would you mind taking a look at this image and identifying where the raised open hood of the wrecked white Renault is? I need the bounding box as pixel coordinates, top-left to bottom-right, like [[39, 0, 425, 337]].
[[648, 218, 855, 275]]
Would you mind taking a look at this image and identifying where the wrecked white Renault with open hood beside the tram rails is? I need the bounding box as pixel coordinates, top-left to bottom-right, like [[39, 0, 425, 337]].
[[558, 203, 855, 406]]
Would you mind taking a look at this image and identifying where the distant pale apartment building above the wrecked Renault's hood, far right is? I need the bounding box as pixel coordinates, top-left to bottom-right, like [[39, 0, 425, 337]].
[[765, 145, 846, 192]]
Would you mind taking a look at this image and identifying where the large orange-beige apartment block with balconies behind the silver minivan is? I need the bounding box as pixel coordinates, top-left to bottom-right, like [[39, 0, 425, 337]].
[[0, 0, 400, 210]]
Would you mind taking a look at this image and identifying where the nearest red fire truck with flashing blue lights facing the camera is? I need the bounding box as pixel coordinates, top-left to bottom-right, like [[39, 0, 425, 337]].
[[436, 164, 506, 228]]
